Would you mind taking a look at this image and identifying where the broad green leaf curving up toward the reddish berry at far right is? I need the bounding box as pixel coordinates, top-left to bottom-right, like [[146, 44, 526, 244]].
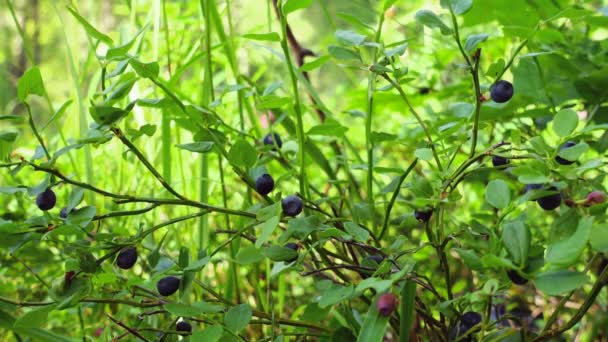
[[545, 217, 593, 267]]
